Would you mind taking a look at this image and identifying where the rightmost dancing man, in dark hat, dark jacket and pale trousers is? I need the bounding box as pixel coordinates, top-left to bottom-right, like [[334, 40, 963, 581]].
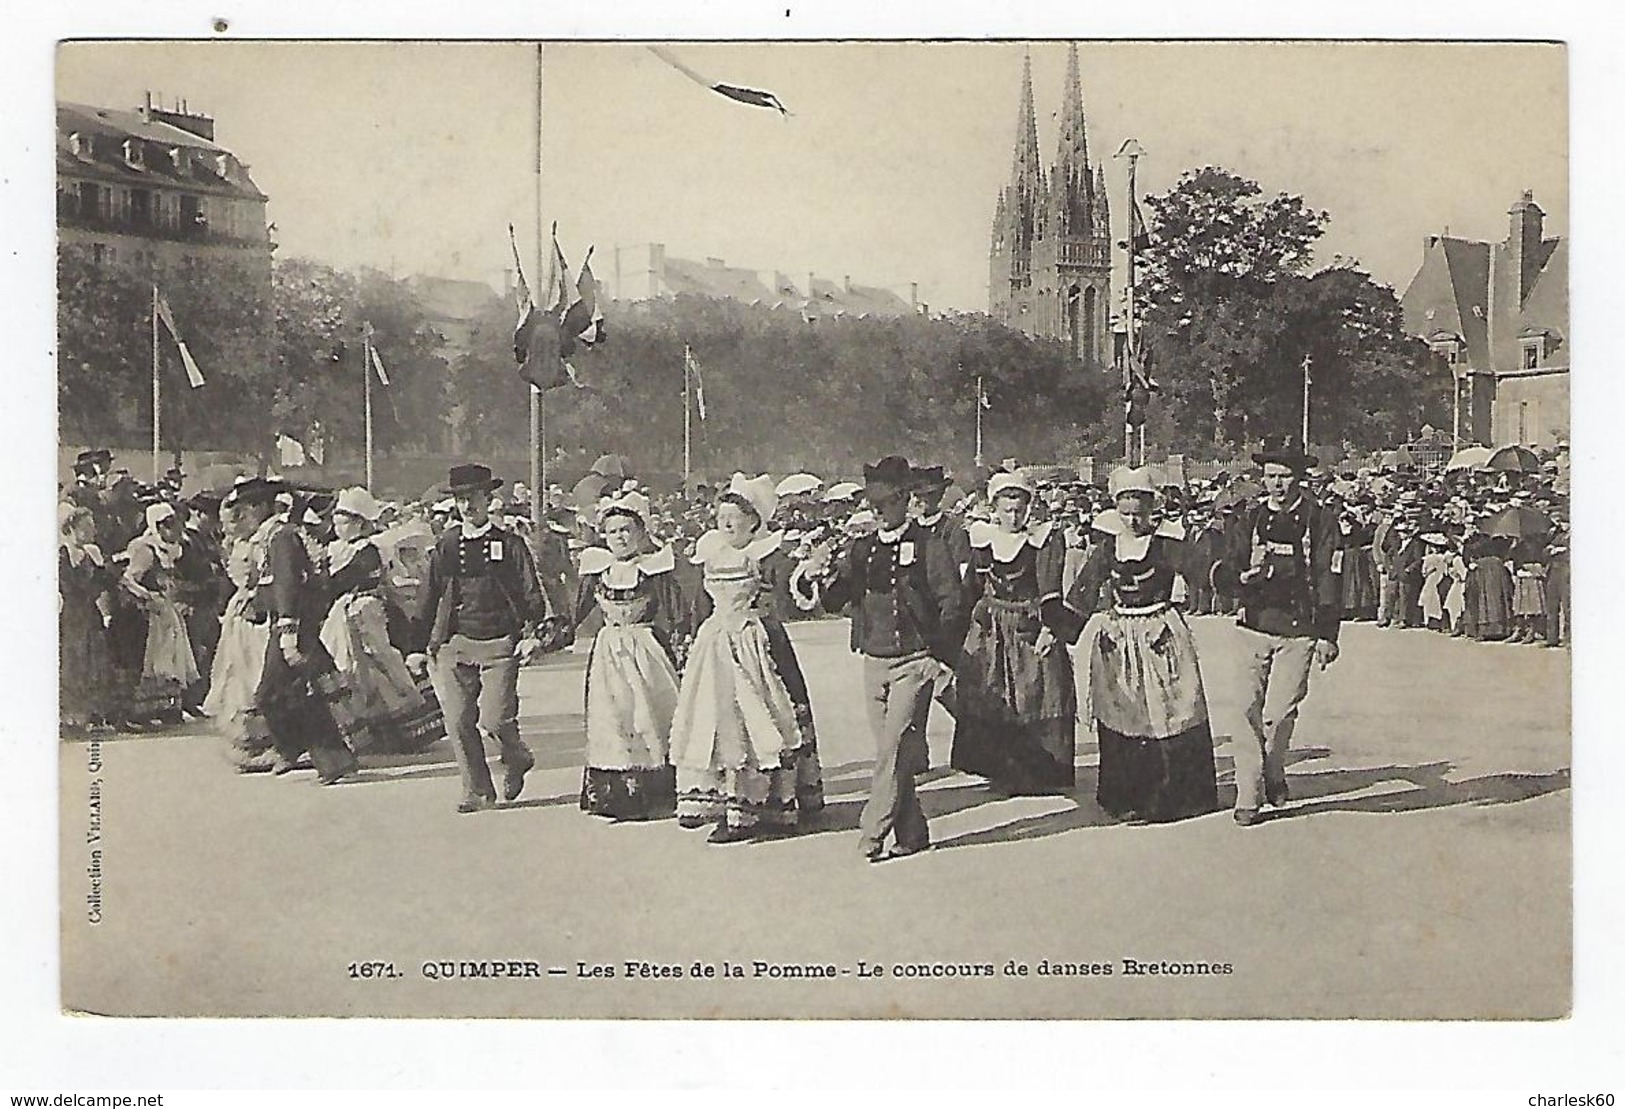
[[1214, 437, 1342, 826]]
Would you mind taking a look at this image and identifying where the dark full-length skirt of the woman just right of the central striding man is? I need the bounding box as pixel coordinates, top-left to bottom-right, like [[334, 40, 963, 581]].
[[951, 600, 1077, 794]]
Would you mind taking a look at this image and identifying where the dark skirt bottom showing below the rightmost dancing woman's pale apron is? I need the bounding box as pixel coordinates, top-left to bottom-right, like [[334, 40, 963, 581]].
[[1095, 720, 1219, 821]]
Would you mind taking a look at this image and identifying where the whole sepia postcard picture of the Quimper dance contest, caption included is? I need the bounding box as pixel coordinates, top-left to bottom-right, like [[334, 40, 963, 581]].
[[36, 30, 1579, 1021]]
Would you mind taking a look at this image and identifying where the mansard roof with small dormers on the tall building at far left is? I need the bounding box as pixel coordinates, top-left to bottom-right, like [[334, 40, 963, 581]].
[[57, 101, 267, 200]]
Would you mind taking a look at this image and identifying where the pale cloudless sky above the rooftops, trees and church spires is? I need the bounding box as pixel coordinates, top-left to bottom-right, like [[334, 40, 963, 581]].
[[57, 41, 1568, 311]]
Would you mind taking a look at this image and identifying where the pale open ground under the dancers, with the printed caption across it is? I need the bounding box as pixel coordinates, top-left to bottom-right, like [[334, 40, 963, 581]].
[[60, 618, 1571, 1018]]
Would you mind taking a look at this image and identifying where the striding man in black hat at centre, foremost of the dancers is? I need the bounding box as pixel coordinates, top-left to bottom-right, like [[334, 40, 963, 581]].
[[801, 455, 965, 862]]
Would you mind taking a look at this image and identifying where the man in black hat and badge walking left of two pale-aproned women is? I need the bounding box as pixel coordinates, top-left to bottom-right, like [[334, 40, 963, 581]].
[[406, 463, 549, 813]]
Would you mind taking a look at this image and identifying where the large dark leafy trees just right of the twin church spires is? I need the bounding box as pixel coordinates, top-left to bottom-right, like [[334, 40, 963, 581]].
[[1136, 167, 1448, 454]]
